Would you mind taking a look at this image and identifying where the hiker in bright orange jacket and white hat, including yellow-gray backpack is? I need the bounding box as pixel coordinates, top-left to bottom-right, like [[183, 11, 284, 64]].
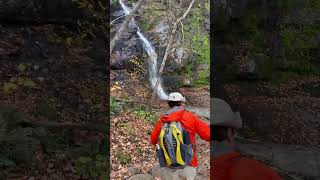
[[150, 92, 210, 180]]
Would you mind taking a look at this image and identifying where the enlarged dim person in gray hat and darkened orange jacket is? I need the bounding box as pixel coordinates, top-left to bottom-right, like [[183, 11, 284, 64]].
[[210, 98, 282, 180]]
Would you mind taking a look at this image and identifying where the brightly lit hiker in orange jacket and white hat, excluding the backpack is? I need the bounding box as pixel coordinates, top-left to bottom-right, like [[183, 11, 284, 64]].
[[150, 92, 210, 180]]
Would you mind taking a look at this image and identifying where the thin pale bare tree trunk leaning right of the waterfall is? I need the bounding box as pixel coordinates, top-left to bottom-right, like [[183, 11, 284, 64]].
[[152, 0, 194, 101]]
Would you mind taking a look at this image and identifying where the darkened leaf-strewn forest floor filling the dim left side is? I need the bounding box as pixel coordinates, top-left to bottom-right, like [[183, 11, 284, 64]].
[[0, 22, 108, 180]]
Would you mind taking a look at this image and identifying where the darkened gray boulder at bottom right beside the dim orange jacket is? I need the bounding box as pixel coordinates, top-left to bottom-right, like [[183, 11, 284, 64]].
[[237, 138, 320, 179]]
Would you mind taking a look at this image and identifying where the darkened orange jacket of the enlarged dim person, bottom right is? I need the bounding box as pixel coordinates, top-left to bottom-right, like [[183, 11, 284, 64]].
[[210, 152, 282, 180]]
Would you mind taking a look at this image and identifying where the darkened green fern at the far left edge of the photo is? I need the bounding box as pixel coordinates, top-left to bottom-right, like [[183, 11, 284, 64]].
[[0, 105, 39, 167]]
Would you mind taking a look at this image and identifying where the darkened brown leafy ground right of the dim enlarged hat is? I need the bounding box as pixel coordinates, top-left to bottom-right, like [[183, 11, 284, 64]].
[[220, 77, 320, 148]]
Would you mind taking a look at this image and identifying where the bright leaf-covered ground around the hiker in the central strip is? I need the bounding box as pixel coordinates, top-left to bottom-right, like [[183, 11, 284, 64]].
[[111, 70, 210, 179]]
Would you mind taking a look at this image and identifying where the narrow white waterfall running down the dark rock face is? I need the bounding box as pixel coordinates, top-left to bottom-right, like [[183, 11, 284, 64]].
[[119, 0, 168, 100]]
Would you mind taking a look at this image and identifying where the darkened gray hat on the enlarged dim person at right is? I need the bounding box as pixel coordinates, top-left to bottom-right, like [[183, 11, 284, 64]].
[[210, 98, 242, 129]]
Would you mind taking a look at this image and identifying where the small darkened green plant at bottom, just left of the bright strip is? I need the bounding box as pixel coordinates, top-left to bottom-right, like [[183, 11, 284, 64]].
[[76, 154, 109, 179]]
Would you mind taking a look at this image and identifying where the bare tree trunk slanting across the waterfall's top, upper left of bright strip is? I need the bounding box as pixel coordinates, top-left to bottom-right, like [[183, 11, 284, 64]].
[[110, 0, 144, 54]]
